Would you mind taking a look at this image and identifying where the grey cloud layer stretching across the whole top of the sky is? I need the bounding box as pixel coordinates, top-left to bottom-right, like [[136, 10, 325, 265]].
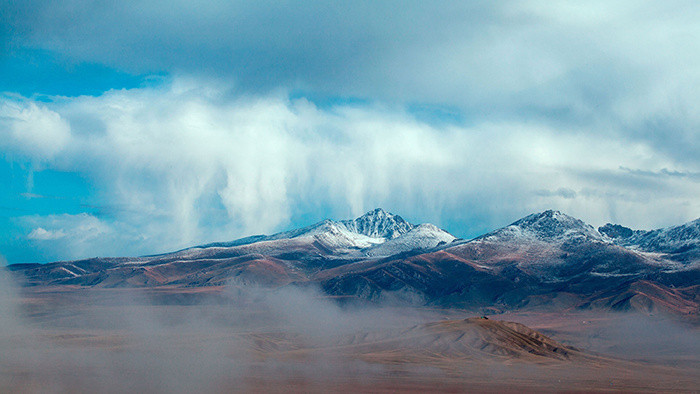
[[2, 0, 700, 162]]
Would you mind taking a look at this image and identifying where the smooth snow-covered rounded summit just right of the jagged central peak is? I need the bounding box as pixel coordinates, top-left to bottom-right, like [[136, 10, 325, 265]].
[[365, 223, 455, 256]]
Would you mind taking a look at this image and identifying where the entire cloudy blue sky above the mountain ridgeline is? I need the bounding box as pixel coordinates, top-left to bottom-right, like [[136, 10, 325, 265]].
[[0, 0, 700, 263]]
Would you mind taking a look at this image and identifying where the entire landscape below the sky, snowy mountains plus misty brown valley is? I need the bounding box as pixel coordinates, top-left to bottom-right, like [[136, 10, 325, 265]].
[[0, 209, 700, 392]]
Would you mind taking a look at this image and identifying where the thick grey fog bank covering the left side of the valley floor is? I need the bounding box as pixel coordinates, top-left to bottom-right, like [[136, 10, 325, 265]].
[[0, 270, 440, 392]]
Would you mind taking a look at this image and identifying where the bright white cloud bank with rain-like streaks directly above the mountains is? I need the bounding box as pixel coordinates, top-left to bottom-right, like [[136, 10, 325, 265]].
[[4, 79, 700, 258]]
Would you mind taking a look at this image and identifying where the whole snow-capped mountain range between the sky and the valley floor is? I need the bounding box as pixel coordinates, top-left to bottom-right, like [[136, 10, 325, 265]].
[[8, 209, 700, 318]]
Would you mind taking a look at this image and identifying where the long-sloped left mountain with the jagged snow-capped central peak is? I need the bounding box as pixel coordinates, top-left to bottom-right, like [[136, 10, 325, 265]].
[[10, 209, 454, 287]]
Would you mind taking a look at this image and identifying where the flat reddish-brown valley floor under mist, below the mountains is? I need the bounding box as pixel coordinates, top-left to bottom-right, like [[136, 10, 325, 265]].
[[0, 287, 700, 393]]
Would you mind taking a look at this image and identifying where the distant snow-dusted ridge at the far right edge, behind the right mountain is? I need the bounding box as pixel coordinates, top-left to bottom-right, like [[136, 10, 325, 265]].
[[599, 218, 700, 253]]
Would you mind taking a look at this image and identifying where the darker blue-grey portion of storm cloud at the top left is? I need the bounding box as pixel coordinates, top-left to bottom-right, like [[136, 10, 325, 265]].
[[1, 1, 491, 90]]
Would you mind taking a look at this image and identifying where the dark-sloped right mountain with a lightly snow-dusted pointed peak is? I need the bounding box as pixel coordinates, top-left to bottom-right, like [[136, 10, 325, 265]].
[[317, 211, 700, 314]]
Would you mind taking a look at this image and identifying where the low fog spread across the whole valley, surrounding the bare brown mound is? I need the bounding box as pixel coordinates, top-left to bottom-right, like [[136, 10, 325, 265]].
[[0, 270, 700, 393]]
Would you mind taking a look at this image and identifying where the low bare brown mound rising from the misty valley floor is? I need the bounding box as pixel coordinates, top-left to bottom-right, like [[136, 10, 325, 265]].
[[253, 318, 582, 364]]
